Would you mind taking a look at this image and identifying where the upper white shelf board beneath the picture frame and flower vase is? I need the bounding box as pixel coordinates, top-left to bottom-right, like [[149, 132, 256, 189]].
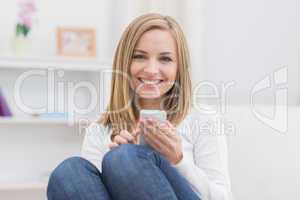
[[0, 56, 111, 71]]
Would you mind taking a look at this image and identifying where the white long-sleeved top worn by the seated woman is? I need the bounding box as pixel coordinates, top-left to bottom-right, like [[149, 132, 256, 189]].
[[81, 112, 232, 200]]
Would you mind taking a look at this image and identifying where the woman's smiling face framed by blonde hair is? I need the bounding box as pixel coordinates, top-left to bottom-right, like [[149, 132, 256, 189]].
[[130, 29, 178, 108]]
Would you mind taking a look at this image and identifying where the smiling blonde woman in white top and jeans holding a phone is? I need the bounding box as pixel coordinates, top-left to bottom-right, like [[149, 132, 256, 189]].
[[47, 14, 234, 200]]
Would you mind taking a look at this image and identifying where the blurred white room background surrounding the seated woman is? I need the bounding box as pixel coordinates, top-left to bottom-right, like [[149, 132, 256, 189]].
[[0, 0, 300, 200]]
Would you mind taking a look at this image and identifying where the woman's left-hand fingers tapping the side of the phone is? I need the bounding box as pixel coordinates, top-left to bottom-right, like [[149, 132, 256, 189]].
[[108, 129, 138, 149]]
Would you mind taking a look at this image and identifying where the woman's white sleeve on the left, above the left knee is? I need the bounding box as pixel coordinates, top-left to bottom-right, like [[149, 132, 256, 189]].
[[81, 123, 110, 172]]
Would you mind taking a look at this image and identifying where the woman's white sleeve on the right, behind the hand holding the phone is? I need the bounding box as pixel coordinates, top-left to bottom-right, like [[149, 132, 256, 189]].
[[175, 114, 232, 200]]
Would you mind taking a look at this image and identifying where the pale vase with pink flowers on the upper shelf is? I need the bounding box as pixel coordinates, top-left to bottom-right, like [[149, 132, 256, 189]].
[[13, 0, 36, 55]]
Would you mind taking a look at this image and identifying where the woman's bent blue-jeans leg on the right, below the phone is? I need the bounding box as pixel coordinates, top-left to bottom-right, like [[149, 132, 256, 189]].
[[102, 144, 180, 199]]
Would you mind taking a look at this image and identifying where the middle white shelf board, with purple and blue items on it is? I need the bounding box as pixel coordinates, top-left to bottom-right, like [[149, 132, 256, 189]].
[[0, 117, 78, 125]]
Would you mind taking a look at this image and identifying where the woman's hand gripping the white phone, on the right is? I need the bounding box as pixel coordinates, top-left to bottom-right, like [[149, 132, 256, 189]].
[[140, 119, 183, 164]]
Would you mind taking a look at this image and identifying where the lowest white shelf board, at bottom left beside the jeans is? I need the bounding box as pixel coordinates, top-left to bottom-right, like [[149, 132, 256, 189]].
[[0, 182, 47, 191]]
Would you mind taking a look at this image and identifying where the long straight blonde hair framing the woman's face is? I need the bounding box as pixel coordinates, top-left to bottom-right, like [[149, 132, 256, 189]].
[[99, 13, 191, 138]]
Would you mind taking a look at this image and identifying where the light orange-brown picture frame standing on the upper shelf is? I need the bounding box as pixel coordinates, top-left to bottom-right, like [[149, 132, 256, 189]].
[[57, 27, 96, 57]]
